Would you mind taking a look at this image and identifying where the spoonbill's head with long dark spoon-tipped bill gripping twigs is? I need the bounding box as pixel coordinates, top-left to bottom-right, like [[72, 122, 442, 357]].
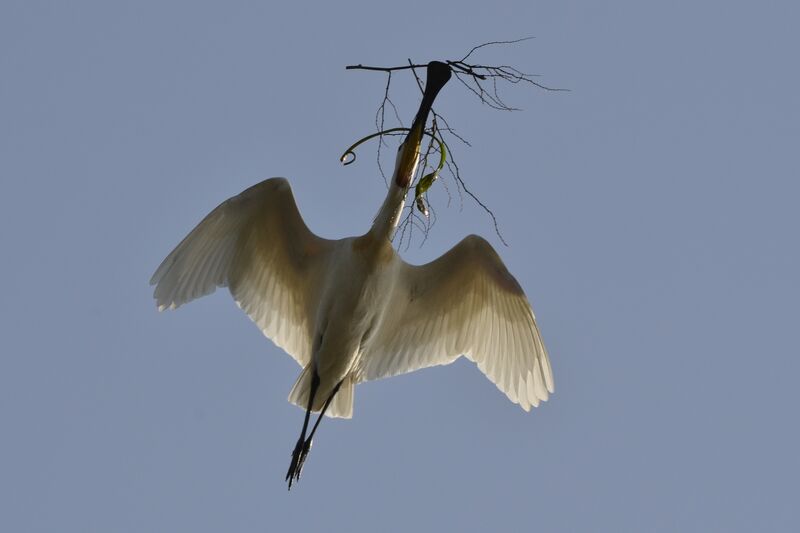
[[392, 61, 451, 189]]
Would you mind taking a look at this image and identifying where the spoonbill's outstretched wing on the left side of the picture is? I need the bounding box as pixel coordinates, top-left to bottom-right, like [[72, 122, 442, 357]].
[[150, 178, 334, 366]]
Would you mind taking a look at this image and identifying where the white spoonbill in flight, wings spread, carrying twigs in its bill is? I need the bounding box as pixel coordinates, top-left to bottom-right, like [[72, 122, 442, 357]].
[[150, 62, 554, 489]]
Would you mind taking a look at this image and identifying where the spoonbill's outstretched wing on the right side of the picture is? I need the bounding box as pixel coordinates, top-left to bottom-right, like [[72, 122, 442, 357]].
[[359, 235, 554, 411]]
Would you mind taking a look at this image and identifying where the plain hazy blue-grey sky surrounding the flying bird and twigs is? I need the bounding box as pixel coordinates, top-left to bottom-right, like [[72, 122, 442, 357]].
[[0, 0, 800, 532]]
